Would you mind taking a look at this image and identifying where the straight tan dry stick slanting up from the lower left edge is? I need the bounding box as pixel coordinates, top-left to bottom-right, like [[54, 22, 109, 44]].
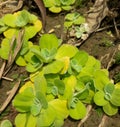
[[0, 80, 20, 114]]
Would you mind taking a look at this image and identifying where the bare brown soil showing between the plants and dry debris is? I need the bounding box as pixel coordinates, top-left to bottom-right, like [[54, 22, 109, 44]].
[[0, 0, 120, 127]]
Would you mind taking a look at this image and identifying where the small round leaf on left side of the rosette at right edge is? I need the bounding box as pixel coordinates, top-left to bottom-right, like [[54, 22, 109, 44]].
[[94, 91, 108, 106]]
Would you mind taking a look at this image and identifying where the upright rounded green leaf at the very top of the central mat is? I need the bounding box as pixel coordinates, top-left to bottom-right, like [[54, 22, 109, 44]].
[[39, 34, 59, 50]]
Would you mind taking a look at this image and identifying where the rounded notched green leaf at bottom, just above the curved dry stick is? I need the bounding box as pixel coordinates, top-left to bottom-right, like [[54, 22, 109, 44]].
[[69, 101, 87, 120]]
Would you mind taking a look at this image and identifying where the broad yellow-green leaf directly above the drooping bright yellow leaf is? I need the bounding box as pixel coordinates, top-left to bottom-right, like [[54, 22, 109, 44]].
[[55, 44, 78, 59]]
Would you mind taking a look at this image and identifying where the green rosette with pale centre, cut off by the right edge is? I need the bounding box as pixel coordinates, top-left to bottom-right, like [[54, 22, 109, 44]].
[[94, 83, 120, 116]]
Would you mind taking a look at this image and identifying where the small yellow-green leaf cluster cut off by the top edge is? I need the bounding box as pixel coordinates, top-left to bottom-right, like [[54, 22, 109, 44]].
[[43, 0, 75, 13]]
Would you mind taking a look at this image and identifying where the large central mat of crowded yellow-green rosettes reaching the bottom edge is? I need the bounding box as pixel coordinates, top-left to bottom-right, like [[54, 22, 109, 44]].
[[8, 34, 120, 127]]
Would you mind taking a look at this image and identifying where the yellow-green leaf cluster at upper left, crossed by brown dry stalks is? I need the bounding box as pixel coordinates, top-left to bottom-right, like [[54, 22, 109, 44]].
[[0, 10, 42, 60]]
